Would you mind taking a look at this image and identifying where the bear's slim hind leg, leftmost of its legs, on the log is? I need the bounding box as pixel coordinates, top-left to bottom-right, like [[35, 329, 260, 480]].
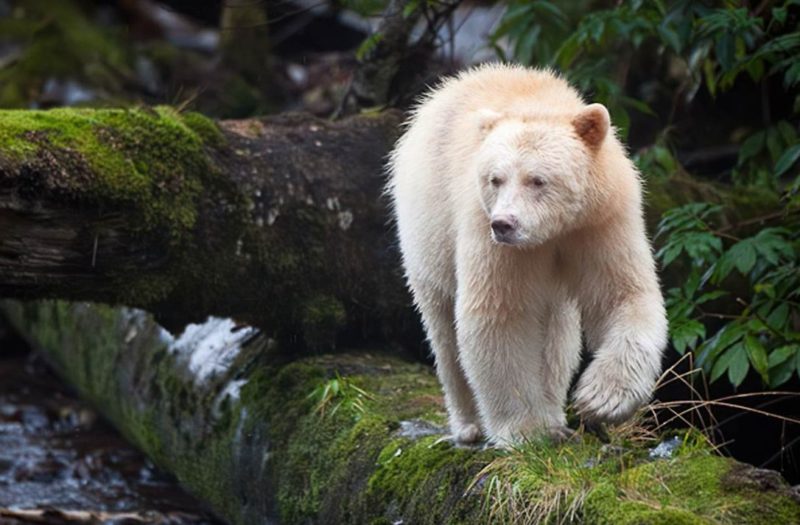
[[411, 284, 481, 443]]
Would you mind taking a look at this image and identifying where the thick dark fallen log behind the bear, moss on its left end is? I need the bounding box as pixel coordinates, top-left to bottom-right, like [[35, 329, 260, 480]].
[[0, 107, 418, 347]]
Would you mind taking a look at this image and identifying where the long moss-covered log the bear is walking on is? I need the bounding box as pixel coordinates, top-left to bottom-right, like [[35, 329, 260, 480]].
[[0, 301, 800, 525]]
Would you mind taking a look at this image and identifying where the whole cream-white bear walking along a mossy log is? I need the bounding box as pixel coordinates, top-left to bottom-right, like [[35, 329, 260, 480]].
[[387, 65, 667, 446]]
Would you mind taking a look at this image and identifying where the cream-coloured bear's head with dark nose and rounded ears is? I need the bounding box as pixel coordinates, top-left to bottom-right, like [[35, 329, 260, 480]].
[[476, 104, 610, 247]]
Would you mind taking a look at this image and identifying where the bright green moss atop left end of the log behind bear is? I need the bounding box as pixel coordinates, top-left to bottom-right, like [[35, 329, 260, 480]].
[[0, 107, 219, 234]]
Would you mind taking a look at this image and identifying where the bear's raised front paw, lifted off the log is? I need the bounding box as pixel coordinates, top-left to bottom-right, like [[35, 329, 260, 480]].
[[573, 363, 652, 423]]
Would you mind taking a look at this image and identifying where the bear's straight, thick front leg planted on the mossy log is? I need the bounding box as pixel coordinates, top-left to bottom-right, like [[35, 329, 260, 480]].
[[458, 312, 568, 446]]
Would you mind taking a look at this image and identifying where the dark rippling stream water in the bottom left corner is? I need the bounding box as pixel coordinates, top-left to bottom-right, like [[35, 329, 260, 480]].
[[0, 321, 223, 525]]
